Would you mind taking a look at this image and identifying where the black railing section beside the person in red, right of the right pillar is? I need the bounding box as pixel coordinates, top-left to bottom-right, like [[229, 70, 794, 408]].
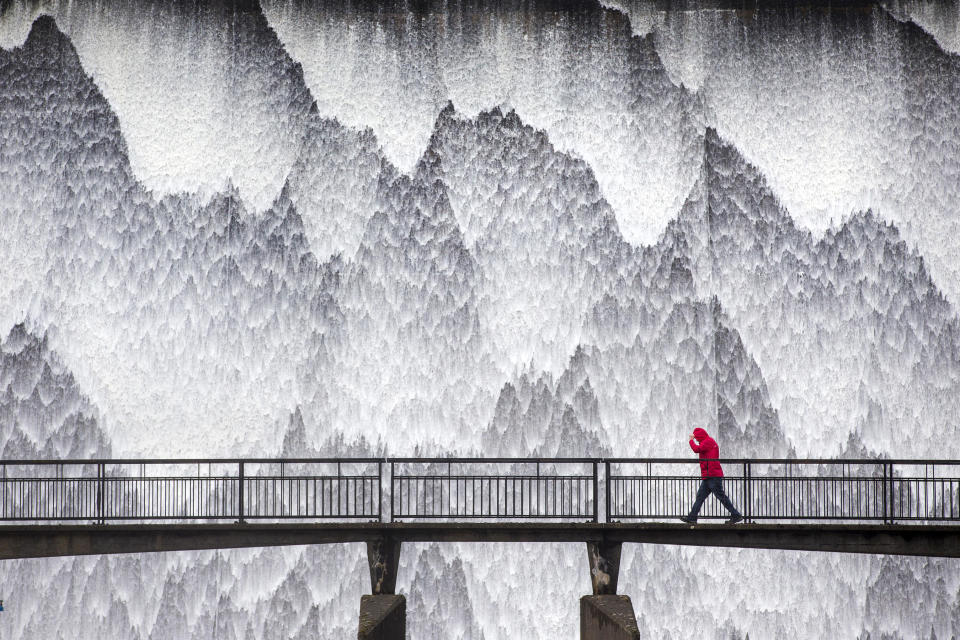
[[604, 458, 960, 523]]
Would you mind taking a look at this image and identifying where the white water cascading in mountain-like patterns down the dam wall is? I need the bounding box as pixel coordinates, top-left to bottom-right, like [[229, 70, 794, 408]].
[[0, 0, 960, 640]]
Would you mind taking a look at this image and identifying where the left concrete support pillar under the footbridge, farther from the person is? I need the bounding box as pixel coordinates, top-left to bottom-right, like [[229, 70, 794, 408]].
[[357, 538, 407, 640]]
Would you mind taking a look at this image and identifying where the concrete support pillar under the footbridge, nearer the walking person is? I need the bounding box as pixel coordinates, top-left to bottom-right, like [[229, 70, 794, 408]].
[[580, 540, 640, 640]]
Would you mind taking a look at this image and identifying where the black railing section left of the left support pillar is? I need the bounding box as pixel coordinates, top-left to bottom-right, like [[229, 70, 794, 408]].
[[0, 458, 383, 523]]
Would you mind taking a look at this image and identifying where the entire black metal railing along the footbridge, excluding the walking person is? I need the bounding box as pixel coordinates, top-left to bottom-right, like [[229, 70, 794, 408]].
[[0, 458, 960, 524]]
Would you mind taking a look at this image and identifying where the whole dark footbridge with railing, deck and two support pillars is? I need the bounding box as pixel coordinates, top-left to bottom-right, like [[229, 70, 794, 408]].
[[0, 458, 960, 639]]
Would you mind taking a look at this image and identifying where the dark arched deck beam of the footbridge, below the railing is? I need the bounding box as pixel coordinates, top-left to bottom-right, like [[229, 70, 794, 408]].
[[0, 522, 960, 559]]
